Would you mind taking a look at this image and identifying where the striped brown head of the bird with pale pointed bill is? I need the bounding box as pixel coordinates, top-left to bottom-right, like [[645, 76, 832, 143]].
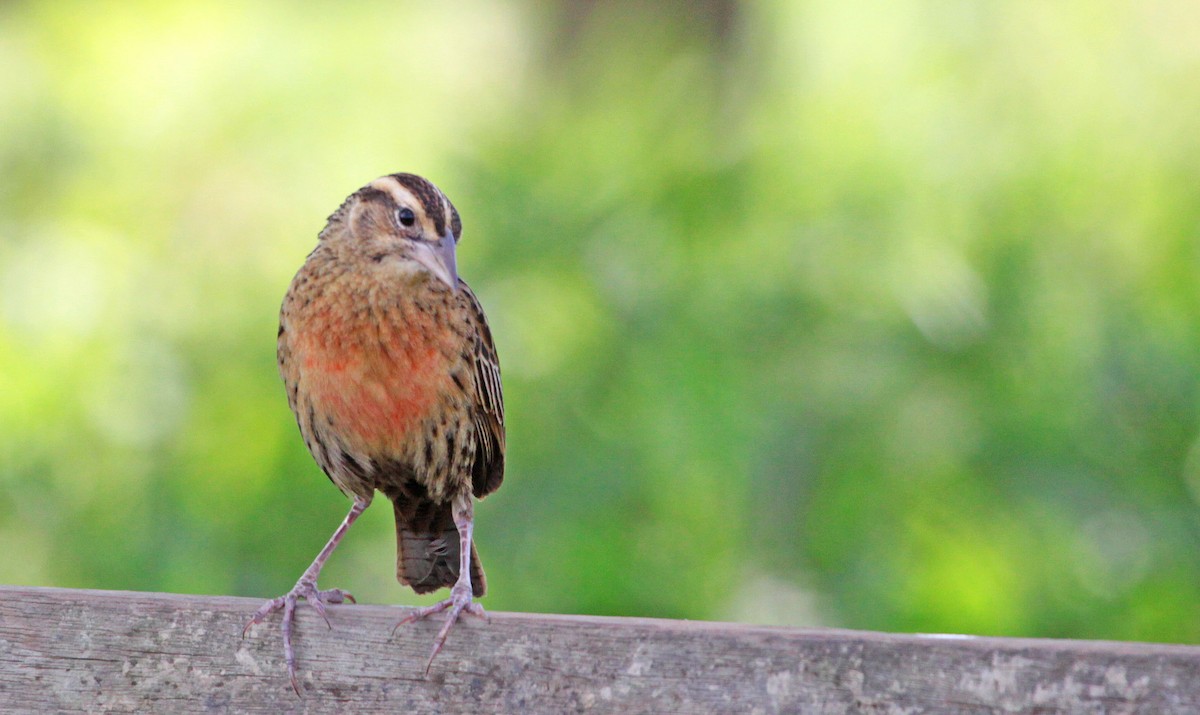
[[319, 174, 462, 290]]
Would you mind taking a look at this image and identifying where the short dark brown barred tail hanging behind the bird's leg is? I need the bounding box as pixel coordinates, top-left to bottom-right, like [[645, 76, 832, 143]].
[[394, 500, 487, 597]]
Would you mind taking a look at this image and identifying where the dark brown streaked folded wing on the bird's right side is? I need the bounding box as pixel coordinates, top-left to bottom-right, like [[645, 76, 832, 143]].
[[458, 280, 504, 498]]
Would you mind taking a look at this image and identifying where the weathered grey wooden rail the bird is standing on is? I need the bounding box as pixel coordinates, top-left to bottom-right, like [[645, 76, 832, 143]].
[[0, 587, 1200, 715]]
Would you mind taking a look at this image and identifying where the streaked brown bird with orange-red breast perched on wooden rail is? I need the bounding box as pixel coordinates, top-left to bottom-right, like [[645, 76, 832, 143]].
[[242, 173, 505, 695]]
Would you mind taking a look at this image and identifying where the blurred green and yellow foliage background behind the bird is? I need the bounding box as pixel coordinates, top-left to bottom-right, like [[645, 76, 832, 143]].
[[0, 0, 1200, 642]]
